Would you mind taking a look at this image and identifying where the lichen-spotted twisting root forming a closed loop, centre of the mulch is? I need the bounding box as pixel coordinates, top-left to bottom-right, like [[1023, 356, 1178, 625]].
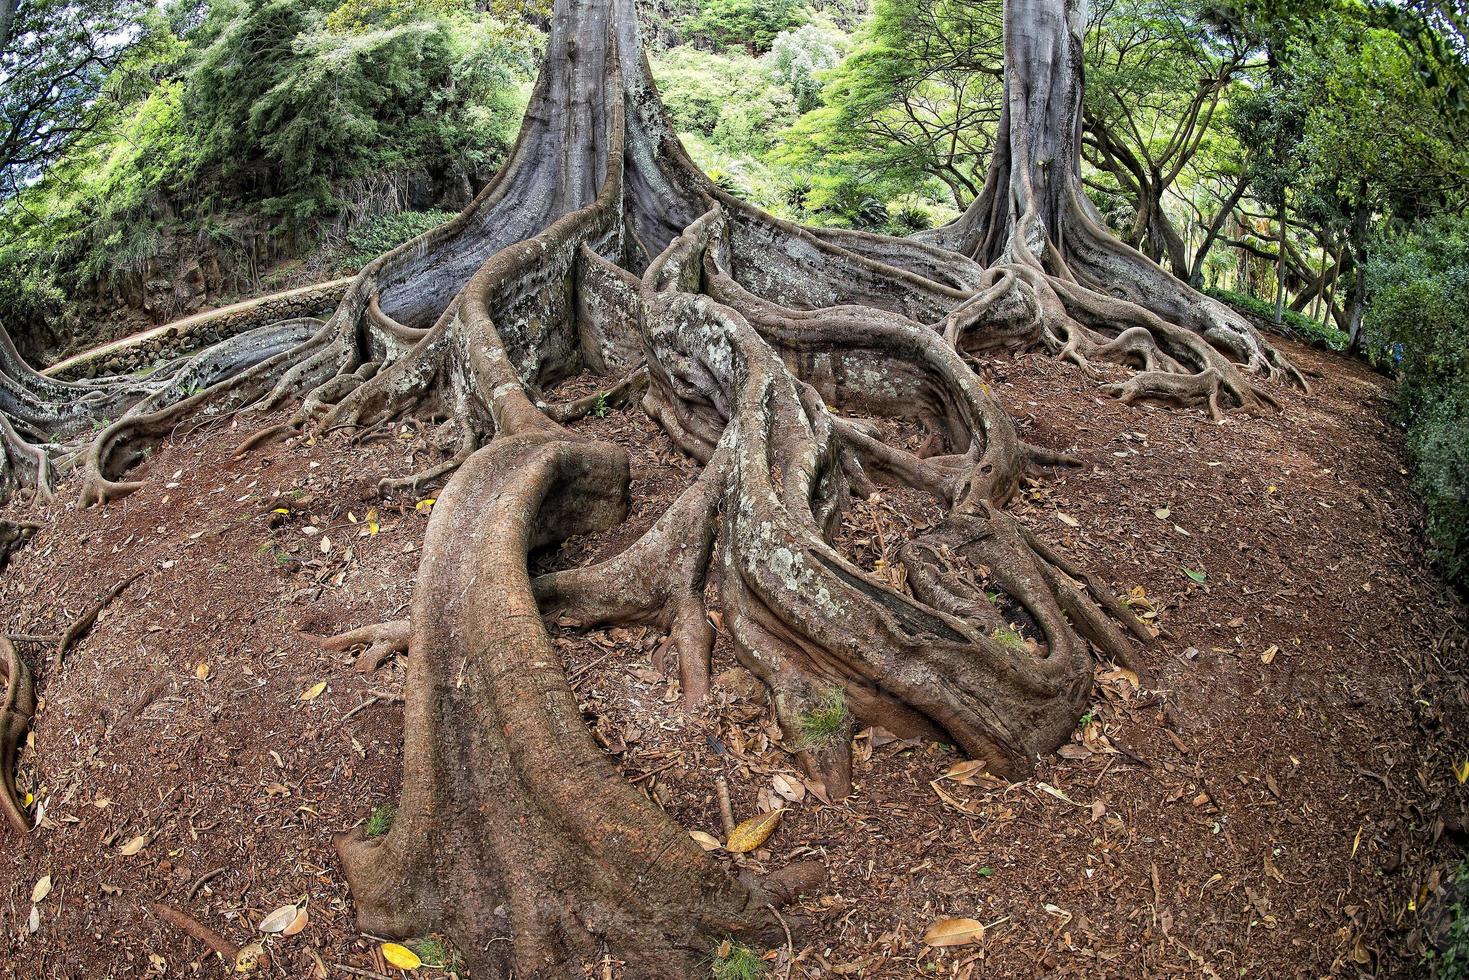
[[643, 209, 1130, 796]]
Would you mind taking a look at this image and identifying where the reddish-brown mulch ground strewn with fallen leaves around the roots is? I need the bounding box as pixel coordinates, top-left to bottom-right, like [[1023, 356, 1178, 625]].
[[0, 334, 1469, 979]]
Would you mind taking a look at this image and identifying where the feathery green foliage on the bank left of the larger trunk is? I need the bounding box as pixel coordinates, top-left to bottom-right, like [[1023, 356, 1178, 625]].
[[0, 0, 535, 348]]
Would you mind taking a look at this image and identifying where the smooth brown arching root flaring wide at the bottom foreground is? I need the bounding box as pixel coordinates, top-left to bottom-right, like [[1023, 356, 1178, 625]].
[[338, 435, 816, 977]]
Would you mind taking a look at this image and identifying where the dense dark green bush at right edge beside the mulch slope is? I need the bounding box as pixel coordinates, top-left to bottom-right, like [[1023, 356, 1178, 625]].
[[1363, 217, 1469, 589]]
